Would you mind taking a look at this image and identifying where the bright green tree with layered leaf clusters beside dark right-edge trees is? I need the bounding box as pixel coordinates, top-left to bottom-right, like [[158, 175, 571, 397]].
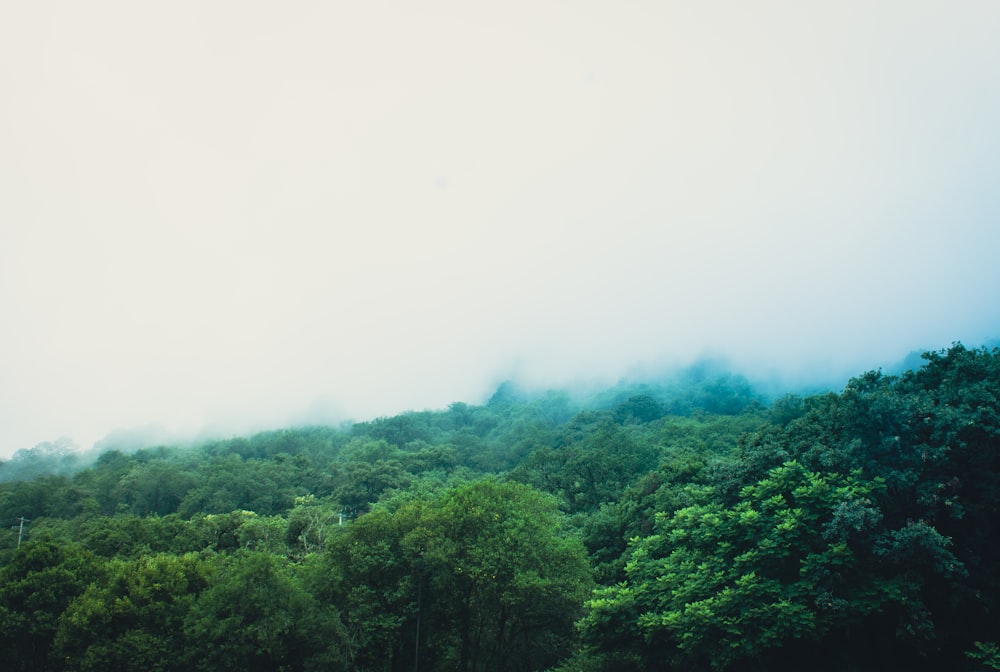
[[582, 462, 903, 670]]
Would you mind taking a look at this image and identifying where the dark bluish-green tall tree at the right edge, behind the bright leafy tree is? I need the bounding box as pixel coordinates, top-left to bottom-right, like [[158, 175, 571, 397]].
[[718, 344, 1000, 664]]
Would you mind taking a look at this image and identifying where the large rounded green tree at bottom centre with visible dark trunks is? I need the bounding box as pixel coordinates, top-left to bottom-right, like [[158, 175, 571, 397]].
[[329, 480, 590, 671]]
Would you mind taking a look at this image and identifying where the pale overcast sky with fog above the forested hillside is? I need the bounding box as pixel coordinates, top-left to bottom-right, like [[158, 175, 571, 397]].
[[0, 0, 1000, 456]]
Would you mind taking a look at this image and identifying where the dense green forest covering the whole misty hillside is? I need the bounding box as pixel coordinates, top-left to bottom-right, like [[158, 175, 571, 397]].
[[0, 343, 1000, 672]]
